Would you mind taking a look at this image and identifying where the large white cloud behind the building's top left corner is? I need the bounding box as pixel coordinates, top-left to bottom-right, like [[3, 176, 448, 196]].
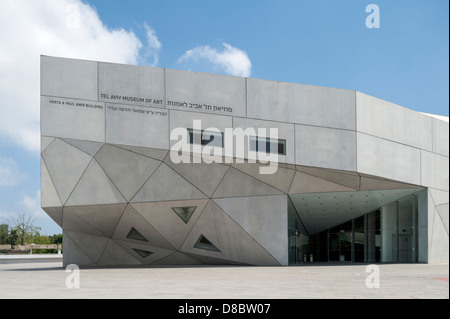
[[0, 0, 161, 151]]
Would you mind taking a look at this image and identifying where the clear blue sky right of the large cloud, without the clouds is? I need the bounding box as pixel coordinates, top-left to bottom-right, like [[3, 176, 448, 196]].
[[89, 0, 449, 115]]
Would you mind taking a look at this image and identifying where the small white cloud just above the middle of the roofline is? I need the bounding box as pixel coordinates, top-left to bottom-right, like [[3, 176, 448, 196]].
[[178, 43, 252, 77]]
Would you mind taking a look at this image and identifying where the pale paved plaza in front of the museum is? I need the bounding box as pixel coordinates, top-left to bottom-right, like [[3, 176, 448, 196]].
[[0, 261, 449, 299]]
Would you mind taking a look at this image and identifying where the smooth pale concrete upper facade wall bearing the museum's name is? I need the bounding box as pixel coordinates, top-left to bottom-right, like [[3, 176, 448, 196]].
[[41, 56, 449, 190]]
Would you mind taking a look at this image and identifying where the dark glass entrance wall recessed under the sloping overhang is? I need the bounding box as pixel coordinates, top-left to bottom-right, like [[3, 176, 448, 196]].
[[288, 190, 426, 264]]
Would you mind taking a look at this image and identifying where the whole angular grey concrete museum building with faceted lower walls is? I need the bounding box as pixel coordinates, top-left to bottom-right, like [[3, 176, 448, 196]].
[[41, 56, 449, 266]]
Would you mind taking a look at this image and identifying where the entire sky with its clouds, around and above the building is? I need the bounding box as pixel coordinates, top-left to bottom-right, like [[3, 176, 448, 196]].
[[0, 0, 449, 234]]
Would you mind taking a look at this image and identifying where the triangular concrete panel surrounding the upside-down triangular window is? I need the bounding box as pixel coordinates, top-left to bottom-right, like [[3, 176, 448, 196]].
[[131, 199, 208, 249]]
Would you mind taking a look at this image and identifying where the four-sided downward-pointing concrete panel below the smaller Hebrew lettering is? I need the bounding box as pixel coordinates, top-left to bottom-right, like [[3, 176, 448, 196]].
[[95, 144, 161, 201]]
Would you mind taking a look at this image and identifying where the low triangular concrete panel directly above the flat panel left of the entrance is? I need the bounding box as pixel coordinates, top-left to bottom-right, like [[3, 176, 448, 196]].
[[212, 167, 283, 198]]
